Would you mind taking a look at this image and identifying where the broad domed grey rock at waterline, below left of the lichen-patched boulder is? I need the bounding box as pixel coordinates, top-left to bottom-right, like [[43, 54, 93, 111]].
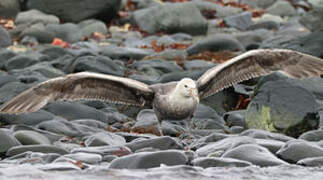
[[222, 144, 288, 167]]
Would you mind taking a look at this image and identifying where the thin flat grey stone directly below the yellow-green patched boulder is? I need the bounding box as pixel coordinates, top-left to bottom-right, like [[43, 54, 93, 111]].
[[240, 129, 295, 142]]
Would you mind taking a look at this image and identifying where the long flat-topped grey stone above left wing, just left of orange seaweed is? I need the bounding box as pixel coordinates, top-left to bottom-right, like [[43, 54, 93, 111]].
[[100, 45, 152, 60]]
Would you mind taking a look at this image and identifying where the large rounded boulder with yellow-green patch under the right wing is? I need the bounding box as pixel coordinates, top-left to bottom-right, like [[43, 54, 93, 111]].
[[246, 81, 319, 137]]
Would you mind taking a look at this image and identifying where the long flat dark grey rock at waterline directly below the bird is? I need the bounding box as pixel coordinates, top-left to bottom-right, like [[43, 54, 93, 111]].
[[109, 150, 188, 169]]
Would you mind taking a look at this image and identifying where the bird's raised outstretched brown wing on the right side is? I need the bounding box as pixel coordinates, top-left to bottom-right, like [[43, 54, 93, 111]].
[[197, 49, 323, 99]]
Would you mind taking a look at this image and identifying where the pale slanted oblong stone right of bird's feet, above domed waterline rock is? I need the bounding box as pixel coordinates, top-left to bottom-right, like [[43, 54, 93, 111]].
[[196, 136, 256, 157]]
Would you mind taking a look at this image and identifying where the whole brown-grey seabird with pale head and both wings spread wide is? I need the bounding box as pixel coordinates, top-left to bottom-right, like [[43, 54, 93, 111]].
[[0, 49, 323, 135]]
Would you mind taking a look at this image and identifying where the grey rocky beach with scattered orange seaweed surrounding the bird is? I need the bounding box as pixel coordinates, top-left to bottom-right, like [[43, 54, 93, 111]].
[[0, 0, 323, 180]]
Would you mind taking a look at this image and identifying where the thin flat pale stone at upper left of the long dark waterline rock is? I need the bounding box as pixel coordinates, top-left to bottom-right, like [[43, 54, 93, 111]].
[[71, 146, 132, 156]]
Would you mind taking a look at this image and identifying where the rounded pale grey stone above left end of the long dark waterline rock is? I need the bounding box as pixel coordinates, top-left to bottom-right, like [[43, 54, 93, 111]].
[[84, 132, 126, 147]]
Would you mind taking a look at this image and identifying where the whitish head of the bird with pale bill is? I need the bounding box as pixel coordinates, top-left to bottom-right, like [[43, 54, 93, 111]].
[[177, 78, 198, 99]]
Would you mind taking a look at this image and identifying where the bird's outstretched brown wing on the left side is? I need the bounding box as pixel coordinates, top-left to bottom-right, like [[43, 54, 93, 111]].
[[0, 72, 154, 114]]
